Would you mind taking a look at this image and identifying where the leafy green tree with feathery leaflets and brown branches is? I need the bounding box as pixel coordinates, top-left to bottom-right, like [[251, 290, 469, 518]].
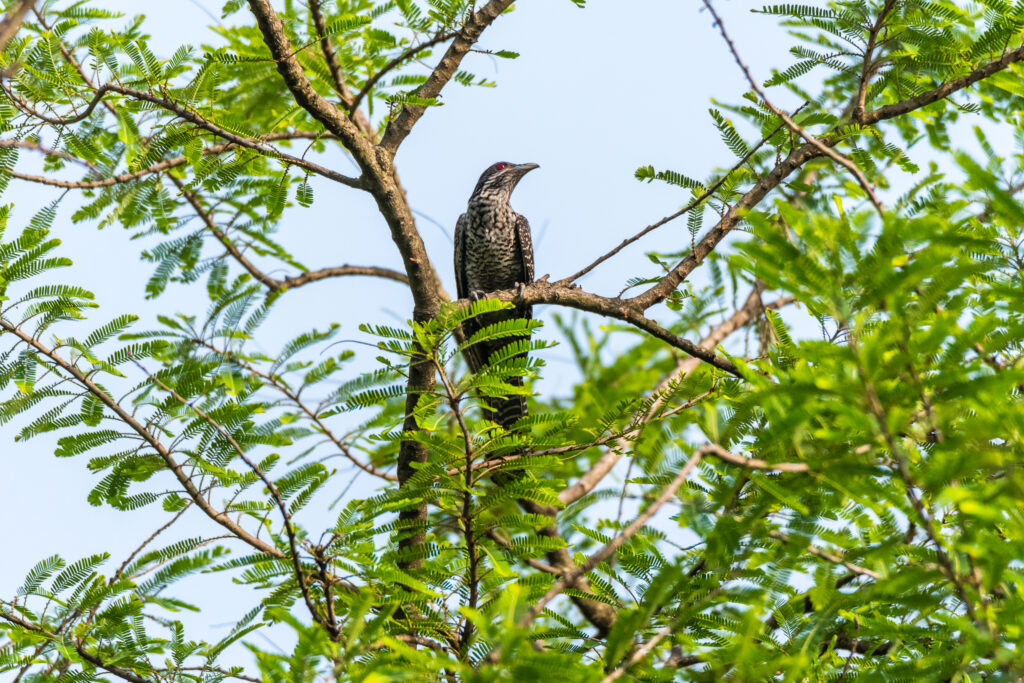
[[0, 0, 1024, 683]]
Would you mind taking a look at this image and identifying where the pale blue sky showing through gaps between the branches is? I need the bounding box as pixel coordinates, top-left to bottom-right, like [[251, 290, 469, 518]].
[[0, 0, 1007, 671]]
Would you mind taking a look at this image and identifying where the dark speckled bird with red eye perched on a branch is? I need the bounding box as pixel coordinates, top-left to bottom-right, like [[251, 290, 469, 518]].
[[455, 162, 540, 429]]
